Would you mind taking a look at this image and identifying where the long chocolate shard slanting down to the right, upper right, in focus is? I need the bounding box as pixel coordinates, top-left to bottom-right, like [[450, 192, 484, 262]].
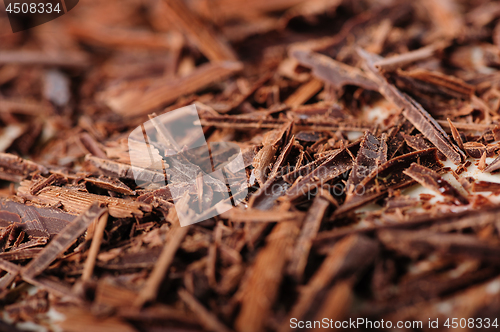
[[358, 49, 465, 165]]
